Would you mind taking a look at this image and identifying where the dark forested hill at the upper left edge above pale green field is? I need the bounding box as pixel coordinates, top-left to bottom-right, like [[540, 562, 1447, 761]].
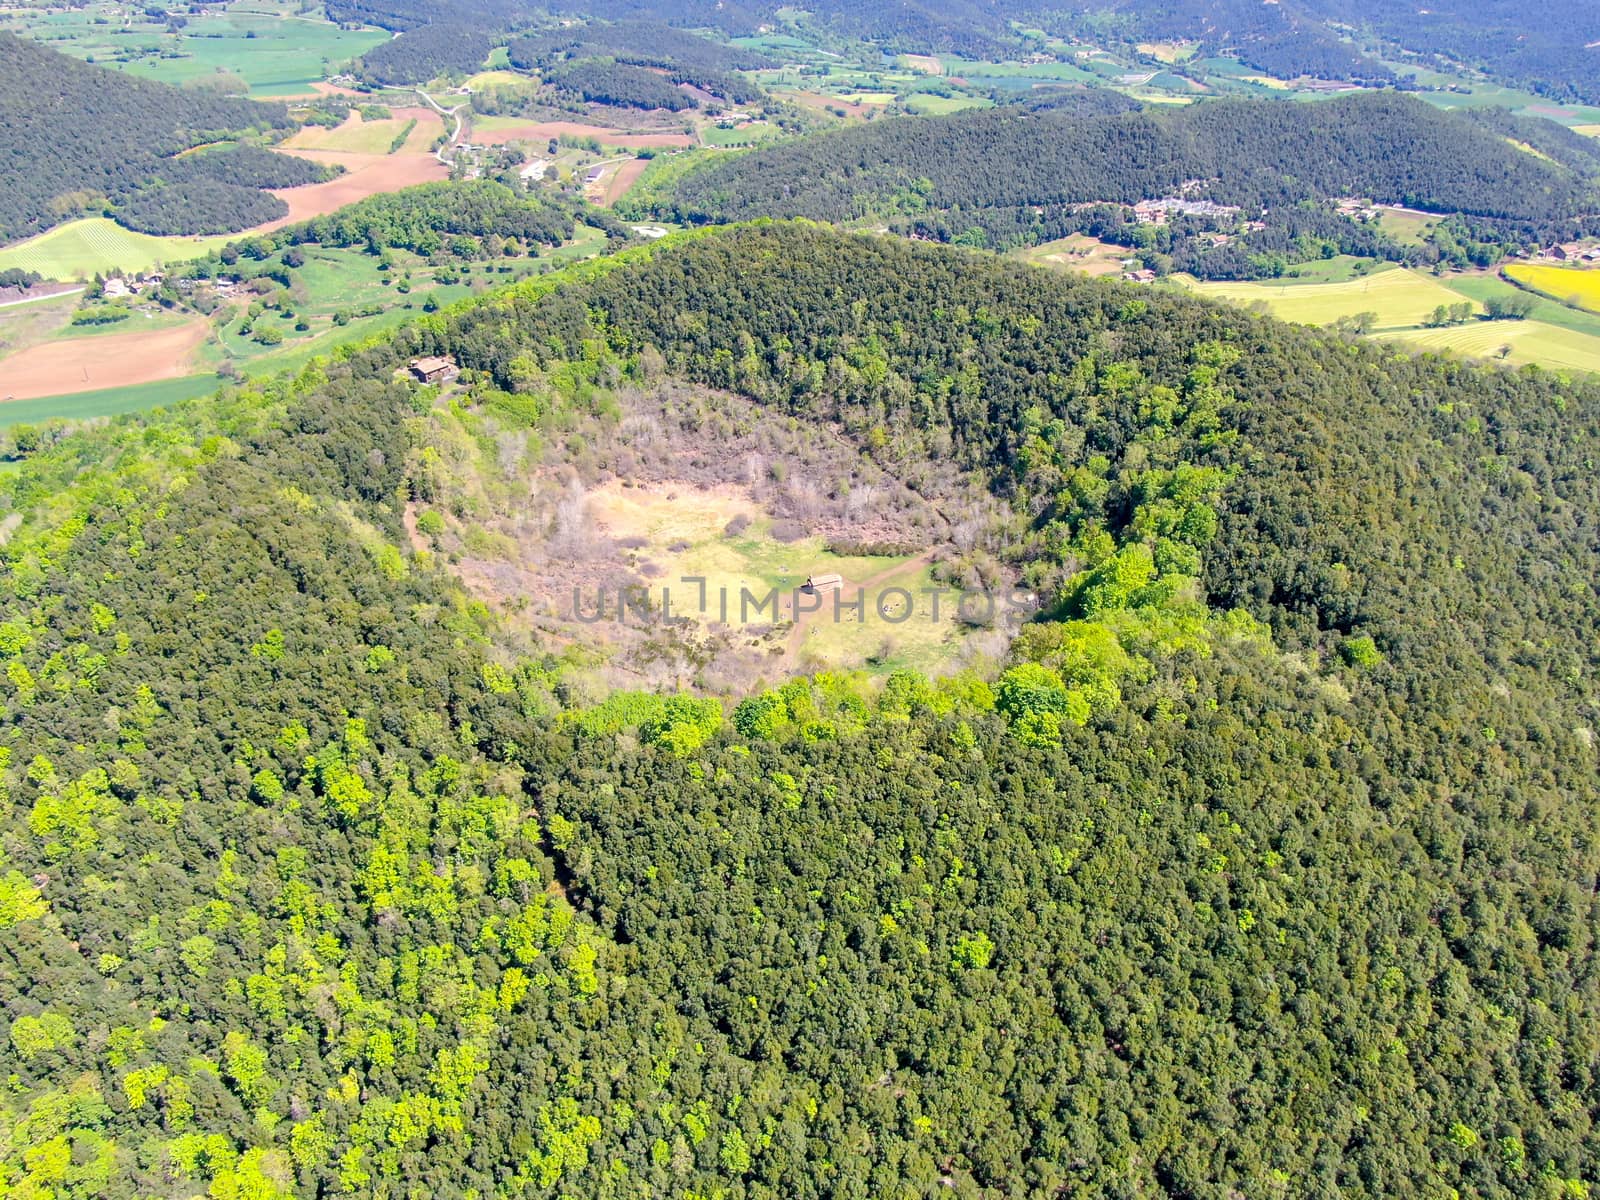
[[0, 32, 308, 242]]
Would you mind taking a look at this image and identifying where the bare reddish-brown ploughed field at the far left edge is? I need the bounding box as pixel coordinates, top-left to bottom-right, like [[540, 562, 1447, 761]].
[[0, 318, 211, 400]]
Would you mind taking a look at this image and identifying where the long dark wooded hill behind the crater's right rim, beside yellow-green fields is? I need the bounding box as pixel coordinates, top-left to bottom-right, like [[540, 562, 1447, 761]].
[[643, 93, 1600, 277]]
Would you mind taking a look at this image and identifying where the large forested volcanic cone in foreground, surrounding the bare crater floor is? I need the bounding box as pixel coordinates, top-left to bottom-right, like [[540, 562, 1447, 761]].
[[0, 224, 1600, 1200]]
